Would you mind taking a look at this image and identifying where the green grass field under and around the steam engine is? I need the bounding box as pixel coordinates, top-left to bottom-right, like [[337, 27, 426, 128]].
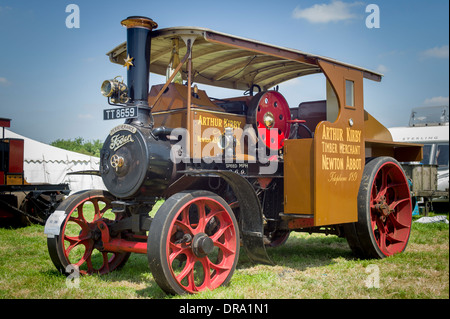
[[0, 210, 449, 299]]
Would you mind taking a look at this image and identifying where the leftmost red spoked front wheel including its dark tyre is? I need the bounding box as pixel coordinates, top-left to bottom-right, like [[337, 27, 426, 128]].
[[46, 190, 130, 275]]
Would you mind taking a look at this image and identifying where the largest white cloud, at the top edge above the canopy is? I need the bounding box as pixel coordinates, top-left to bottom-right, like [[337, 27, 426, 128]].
[[292, 0, 362, 23]]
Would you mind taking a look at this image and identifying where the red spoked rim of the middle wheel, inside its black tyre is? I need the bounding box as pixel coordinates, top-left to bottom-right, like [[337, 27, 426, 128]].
[[166, 197, 237, 293]]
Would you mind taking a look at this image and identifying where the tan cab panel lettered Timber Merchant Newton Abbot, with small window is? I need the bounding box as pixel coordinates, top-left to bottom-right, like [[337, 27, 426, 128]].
[[314, 61, 365, 226]]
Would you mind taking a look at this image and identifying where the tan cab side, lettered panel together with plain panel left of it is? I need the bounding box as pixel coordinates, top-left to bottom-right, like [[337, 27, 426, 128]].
[[284, 61, 365, 226]]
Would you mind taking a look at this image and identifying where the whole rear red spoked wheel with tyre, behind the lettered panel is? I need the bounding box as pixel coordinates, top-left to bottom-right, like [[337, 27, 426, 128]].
[[345, 157, 412, 258]]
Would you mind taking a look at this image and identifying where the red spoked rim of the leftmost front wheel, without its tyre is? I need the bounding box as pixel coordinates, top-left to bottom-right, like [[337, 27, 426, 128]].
[[60, 197, 127, 275]]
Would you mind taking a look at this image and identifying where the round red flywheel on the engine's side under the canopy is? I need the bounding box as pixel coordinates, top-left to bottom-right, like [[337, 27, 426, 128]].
[[248, 91, 291, 150]]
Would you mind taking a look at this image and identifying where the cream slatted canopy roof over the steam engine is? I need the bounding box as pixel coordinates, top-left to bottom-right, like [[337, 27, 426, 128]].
[[107, 27, 382, 90]]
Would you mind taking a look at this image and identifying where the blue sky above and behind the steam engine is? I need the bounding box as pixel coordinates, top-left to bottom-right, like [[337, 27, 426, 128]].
[[0, 0, 449, 143]]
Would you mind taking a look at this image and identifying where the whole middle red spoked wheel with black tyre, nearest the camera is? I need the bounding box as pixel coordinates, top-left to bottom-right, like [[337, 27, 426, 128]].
[[147, 191, 239, 294]]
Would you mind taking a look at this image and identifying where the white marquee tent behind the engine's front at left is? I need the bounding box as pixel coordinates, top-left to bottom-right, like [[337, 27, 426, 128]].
[[5, 130, 106, 193]]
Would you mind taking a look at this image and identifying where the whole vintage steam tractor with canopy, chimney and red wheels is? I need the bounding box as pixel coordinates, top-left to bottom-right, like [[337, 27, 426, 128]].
[[45, 17, 422, 294]]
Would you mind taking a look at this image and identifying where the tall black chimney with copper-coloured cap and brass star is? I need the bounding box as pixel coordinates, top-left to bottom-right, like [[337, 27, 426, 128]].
[[121, 16, 158, 124]]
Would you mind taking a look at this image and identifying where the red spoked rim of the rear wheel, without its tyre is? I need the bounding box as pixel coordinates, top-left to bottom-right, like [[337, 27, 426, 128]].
[[370, 162, 412, 256]]
